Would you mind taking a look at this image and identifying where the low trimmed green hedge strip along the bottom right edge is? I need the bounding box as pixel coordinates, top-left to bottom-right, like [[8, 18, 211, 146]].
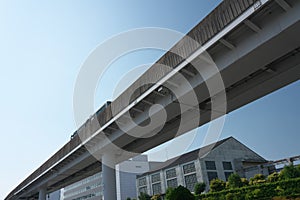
[[195, 178, 300, 200]]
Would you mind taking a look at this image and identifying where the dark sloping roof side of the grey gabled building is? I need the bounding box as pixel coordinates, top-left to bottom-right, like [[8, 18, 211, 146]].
[[138, 137, 236, 177]]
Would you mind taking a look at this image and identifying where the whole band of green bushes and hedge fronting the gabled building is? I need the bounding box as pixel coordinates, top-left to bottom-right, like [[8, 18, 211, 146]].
[[139, 165, 300, 200]]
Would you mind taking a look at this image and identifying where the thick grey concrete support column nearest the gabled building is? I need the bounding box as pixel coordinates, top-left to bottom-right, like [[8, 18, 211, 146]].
[[102, 154, 117, 200]]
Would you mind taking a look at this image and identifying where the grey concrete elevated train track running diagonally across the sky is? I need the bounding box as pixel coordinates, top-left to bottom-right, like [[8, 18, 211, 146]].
[[6, 0, 300, 200]]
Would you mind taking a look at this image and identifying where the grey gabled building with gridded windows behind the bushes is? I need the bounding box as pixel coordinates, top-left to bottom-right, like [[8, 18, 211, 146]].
[[136, 137, 272, 196]]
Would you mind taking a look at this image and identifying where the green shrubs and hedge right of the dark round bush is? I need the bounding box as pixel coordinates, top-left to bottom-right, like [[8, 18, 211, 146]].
[[196, 165, 300, 200]]
